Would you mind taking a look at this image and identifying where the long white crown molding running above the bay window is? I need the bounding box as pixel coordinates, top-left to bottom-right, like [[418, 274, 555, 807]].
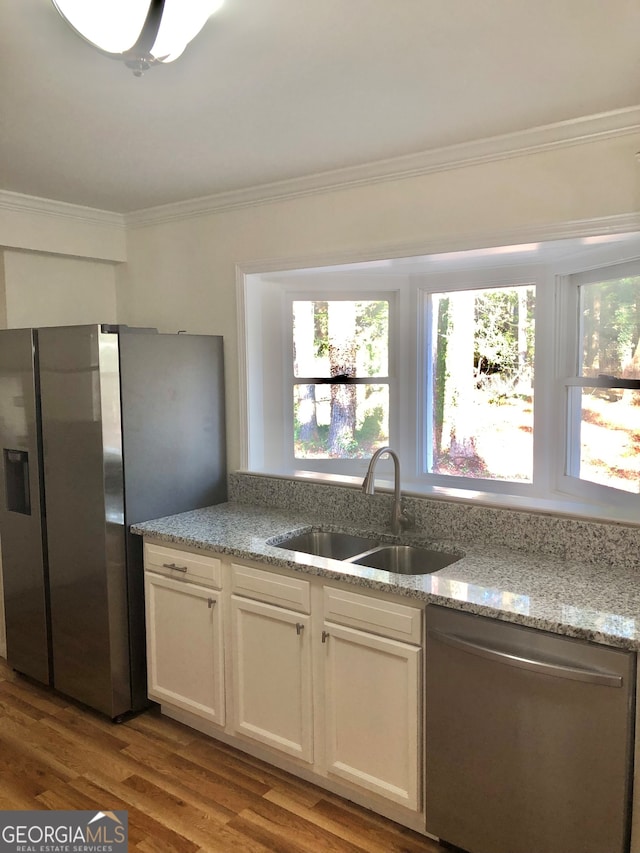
[[125, 106, 640, 227]]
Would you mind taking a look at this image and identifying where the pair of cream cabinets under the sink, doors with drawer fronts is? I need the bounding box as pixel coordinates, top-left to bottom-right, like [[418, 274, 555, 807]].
[[231, 563, 422, 811]]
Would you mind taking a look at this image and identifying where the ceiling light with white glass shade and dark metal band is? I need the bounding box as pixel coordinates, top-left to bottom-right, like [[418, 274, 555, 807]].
[[52, 0, 223, 77]]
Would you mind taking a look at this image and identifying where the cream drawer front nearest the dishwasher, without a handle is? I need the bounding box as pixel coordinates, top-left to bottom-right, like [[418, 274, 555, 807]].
[[324, 587, 422, 646]]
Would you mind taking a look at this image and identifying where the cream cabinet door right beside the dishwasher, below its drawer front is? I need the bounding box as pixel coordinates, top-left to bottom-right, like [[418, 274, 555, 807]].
[[323, 622, 422, 811]]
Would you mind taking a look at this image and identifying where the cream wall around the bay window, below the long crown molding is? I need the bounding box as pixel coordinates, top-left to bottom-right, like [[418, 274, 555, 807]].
[[118, 134, 640, 470]]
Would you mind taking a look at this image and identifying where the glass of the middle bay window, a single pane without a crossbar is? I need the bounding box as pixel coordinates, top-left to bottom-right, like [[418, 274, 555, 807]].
[[426, 284, 536, 483]]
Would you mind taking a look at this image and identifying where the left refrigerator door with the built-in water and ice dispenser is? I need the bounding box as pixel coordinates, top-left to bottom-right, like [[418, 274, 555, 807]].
[[0, 329, 51, 684]]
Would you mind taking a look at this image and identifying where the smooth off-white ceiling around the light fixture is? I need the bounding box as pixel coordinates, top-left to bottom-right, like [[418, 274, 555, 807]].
[[0, 0, 640, 212]]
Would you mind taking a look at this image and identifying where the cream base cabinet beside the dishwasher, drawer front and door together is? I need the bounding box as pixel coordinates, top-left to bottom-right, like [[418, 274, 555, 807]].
[[322, 586, 422, 811]]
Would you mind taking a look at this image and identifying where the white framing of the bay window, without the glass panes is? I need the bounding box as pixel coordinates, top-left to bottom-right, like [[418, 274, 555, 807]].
[[238, 229, 640, 518]]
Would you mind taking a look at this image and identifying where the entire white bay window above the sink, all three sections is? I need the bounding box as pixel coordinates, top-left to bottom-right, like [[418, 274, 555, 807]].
[[242, 230, 640, 514]]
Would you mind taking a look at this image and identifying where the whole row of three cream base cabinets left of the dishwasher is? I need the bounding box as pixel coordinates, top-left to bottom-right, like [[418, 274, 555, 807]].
[[145, 546, 422, 819]]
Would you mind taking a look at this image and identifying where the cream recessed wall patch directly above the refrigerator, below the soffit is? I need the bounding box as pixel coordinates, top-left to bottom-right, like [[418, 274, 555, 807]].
[[0, 250, 117, 329]]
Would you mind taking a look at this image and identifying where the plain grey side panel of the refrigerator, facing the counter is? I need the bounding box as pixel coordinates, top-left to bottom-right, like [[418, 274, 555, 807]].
[[120, 328, 227, 708]]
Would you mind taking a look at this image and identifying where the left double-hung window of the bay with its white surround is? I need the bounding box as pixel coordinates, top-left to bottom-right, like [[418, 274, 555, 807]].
[[245, 271, 400, 477]]
